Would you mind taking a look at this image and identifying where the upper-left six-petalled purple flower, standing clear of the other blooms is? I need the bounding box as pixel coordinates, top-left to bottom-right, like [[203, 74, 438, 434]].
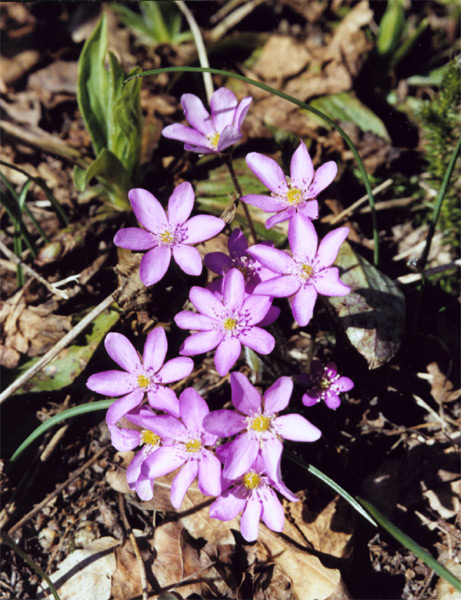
[[114, 181, 225, 285]]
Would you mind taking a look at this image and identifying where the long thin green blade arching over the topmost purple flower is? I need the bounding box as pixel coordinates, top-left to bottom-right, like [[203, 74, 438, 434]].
[[125, 67, 379, 266]]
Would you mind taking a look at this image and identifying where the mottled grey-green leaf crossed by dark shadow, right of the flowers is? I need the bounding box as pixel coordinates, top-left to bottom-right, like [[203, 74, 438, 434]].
[[328, 242, 405, 369]]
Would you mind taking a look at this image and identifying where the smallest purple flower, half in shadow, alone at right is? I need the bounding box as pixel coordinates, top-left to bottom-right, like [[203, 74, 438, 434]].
[[298, 360, 354, 409]]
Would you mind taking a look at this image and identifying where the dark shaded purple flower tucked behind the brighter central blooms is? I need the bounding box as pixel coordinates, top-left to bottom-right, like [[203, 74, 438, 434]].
[[204, 229, 274, 294]]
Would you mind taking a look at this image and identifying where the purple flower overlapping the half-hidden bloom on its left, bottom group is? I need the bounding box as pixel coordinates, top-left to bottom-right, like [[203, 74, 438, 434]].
[[141, 388, 221, 509]]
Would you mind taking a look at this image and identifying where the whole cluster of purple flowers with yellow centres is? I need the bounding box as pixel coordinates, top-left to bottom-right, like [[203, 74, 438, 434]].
[[87, 88, 353, 541]]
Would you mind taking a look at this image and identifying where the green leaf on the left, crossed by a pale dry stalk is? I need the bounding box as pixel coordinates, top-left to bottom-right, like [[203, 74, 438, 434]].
[[16, 309, 120, 394]]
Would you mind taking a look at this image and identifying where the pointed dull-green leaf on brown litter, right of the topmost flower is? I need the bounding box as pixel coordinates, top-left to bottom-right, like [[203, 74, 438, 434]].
[[309, 92, 390, 142]]
